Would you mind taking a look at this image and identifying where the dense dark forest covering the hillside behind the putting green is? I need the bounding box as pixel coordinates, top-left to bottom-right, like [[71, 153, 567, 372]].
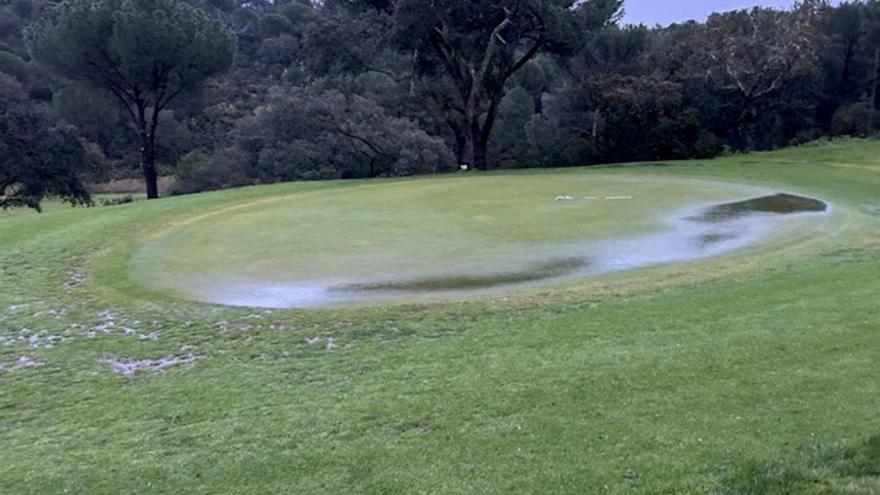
[[0, 0, 880, 206]]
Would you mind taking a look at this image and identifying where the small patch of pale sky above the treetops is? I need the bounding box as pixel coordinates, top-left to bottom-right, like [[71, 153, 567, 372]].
[[624, 0, 820, 26]]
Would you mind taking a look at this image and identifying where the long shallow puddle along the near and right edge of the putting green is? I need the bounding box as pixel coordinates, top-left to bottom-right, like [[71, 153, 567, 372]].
[[175, 193, 830, 308]]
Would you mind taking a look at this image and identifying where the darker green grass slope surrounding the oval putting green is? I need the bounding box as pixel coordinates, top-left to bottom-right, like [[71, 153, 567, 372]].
[[0, 142, 880, 494]]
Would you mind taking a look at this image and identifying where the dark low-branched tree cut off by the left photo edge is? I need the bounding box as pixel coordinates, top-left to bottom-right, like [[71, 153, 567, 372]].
[[0, 73, 91, 211]]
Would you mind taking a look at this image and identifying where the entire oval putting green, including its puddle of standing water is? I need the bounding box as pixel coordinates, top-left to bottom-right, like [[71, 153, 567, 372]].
[[130, 172, 828, 308]]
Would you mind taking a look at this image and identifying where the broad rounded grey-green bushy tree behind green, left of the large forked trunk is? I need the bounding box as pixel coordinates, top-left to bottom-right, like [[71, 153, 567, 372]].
[[233, 90, 455, 181]]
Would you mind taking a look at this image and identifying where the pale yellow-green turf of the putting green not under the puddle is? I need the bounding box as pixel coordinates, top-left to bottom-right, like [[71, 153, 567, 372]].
[[125, 174, 756, 301]]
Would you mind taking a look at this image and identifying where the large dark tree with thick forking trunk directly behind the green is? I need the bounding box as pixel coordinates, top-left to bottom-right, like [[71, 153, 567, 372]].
[[393, 0, 620, 168]]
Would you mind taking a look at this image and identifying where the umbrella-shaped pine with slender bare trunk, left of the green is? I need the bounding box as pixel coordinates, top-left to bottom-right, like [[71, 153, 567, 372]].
[[26, 0, 235, 199]]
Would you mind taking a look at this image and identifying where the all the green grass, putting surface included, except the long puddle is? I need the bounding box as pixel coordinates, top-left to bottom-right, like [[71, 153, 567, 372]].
[[0, 141, 880, 495]]
